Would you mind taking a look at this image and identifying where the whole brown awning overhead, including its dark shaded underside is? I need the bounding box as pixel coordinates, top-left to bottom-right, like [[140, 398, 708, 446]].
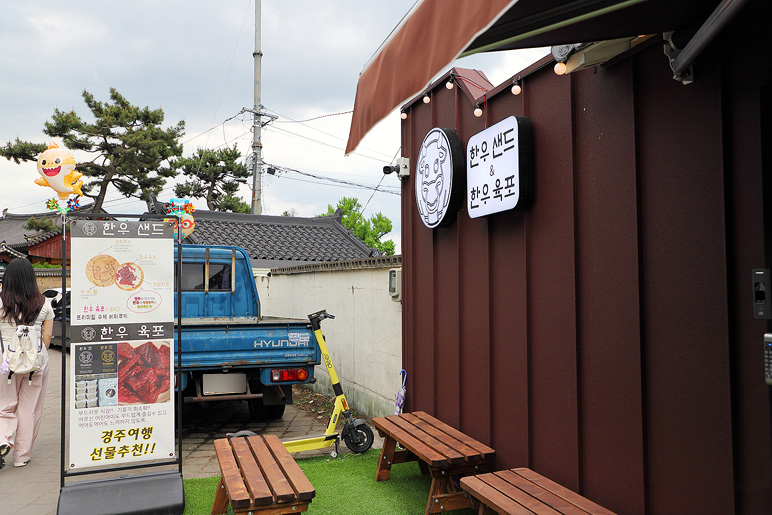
[[346, 0, 732, 154]]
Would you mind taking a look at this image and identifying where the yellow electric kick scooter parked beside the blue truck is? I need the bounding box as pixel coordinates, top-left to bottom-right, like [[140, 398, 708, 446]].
[[282, 310, 374, 458]]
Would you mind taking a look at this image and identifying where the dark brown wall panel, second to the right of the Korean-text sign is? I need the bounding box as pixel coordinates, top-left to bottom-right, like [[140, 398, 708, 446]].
[[574, 61, 645, 513]]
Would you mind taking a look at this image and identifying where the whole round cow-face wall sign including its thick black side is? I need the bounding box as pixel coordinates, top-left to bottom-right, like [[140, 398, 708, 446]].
[[415, 127, 466, 229]]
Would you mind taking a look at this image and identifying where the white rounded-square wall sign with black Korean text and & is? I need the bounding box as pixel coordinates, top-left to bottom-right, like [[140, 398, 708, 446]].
[[466, 116, 523, 218]]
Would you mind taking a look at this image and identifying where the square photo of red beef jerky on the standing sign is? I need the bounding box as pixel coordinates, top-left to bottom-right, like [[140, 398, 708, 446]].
[[118, 341, 171, 406]]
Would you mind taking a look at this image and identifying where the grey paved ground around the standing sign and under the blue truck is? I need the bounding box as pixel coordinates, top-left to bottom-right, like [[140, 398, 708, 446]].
[[0, 349, 382, 515]]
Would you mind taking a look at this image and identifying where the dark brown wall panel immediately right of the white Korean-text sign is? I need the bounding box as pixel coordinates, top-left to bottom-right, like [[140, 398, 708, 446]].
[[524, 70, 579, 489]]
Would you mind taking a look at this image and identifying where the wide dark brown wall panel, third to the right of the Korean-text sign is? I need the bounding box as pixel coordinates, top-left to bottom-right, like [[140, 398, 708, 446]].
[[637, 47, 734, 513]]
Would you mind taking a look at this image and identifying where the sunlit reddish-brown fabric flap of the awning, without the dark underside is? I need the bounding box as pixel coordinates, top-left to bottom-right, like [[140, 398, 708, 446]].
[[346, 0, 517, 154]]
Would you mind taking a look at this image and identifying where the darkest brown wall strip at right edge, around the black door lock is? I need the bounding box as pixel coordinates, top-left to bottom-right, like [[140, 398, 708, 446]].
[[724, 39, 772, 513]]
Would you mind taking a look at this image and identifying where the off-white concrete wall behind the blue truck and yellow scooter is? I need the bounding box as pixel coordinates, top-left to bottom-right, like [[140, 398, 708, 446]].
[[256, 264, 402, 417]]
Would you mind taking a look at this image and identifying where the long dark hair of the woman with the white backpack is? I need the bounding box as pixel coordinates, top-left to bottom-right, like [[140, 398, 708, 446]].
[[0, 258, 45, 325]]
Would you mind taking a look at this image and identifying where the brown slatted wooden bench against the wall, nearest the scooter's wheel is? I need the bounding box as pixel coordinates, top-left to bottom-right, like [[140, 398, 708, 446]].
[[373, 411, 495, 514]]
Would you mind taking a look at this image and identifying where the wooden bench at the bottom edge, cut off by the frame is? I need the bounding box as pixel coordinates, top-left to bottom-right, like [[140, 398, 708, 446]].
[[461, 468, 614, 515]]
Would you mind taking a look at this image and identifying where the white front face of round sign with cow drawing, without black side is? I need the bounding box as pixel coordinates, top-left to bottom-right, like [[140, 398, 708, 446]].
[[415, 129, 453, 228]]
